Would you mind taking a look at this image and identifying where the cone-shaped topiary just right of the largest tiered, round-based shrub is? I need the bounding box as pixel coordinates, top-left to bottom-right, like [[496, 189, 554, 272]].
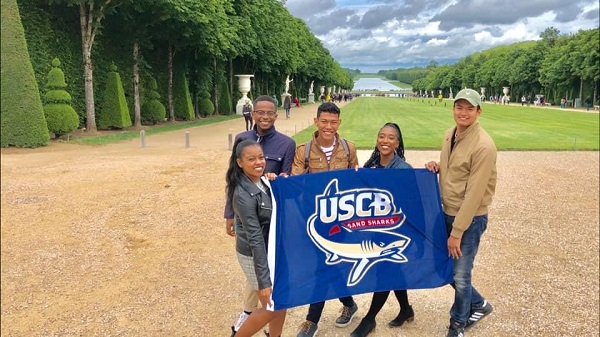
[[97, 63, 131, 129]]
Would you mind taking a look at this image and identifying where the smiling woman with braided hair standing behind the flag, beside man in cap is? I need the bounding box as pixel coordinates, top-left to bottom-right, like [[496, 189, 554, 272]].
[[350, 123, 415, 337]]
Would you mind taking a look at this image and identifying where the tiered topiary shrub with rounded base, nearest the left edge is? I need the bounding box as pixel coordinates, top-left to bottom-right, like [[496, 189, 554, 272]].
[[44, 58, 79, 138]]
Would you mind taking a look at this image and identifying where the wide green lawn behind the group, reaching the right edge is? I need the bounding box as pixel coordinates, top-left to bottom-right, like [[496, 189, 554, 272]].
[[294, 97, 600, 150]]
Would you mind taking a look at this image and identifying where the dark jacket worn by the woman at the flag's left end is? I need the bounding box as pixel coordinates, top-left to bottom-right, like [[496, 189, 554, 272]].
[[233, 176, 272, 289]]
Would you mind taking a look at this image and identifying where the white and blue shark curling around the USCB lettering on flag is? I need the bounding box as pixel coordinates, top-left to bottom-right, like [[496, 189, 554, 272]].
[[307, 180, 410, 286]]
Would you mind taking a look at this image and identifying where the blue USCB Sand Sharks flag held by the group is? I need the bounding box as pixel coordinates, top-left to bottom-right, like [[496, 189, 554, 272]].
[[269, 169, 452, 310]]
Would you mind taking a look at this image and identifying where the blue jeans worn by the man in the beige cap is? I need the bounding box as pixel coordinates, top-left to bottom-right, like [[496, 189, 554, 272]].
[[444, 214, 488, 326]]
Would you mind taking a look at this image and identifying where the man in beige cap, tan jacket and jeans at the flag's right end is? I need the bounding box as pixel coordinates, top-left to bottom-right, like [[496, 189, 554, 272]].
[[425, 89, 496, 337]]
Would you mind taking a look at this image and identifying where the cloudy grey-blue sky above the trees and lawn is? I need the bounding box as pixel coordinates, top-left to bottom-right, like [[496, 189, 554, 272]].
[[286, 0, 599, 73]]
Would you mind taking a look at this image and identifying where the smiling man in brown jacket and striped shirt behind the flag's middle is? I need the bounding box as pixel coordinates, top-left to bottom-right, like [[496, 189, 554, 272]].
[[292, 102, 358, 337]]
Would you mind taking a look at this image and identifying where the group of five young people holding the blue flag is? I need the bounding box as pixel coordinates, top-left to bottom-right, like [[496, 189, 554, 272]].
[[224, 89, 496, 337]]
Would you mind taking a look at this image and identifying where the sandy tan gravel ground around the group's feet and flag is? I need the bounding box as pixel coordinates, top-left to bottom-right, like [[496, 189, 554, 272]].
[[1, 100, 599, 337]]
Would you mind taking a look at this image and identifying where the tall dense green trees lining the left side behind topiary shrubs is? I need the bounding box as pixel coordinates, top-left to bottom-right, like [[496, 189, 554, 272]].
[[3, 0, 353, 144]]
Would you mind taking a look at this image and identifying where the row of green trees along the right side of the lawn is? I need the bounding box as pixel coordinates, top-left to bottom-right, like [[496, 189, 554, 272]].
[[379, 27, 600, 105]]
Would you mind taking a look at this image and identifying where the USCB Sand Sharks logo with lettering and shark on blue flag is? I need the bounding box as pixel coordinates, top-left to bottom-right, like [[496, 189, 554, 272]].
[[307, 179, 410, 286]]
